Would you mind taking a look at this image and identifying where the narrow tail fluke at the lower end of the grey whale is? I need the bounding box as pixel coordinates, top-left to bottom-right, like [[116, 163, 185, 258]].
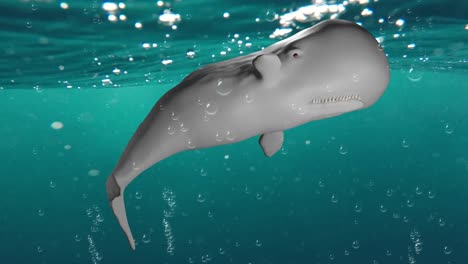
[[106, 175, 135, 250]]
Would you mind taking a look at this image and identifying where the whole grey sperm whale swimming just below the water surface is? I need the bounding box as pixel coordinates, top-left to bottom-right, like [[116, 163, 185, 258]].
[[106, 19, 390, 250]]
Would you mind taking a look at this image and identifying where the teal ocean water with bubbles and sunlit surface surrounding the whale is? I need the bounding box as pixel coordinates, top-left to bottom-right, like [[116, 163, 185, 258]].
[[0, 0, 468, 264]]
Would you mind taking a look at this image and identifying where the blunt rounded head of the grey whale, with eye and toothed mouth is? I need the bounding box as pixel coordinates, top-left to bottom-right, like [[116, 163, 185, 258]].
[[254, 20, 390, 125]]
